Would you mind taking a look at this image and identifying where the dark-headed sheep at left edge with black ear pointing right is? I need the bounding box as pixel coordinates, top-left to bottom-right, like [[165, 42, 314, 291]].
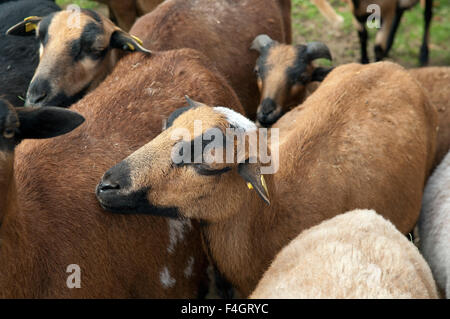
[[0, 98, 84, 225]]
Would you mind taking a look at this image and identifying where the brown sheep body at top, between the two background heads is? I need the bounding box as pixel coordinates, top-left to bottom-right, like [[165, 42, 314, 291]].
[[130, 0, 291, 119]]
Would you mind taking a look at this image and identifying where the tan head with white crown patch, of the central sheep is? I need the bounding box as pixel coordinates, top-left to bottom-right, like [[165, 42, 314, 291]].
[[97, 97, 269, 221]]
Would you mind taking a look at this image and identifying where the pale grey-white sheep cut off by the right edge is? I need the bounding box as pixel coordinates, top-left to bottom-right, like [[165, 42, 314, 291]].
[[418, 153, 450, 298]]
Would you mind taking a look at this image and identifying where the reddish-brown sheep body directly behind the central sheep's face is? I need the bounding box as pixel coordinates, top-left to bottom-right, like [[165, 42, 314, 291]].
[[0, 49, 242, 298]]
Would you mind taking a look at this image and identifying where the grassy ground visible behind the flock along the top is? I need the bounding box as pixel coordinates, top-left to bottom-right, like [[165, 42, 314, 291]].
[[56, 0, 450, 67]]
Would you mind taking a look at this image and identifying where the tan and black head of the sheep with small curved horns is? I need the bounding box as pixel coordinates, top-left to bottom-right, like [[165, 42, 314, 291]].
[[251, 35, 331, 126]]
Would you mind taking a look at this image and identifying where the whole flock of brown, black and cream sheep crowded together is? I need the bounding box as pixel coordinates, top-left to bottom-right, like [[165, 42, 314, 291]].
[[0, 0, 450, 298]]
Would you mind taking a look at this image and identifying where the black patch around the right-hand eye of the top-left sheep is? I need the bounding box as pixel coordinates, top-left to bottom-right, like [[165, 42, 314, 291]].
[[69, 22, 108, 63]]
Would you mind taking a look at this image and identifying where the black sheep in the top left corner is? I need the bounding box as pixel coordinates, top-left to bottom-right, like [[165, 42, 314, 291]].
[[0, 0, 60, 106]]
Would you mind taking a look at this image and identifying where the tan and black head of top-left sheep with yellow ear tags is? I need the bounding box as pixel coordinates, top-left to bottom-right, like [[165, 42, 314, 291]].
[[7, 9, 150, 106]]
